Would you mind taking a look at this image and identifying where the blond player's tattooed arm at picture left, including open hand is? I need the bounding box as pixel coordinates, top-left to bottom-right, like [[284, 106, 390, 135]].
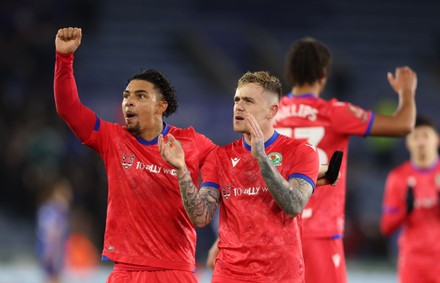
[[158, 134, 220, 228]]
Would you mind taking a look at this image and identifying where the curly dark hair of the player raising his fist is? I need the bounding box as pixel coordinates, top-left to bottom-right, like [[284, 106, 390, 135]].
[[128, 69, 179, 117]]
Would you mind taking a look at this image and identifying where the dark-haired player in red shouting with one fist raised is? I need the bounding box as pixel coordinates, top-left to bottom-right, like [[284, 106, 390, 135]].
[[54, 27, 216, 283]]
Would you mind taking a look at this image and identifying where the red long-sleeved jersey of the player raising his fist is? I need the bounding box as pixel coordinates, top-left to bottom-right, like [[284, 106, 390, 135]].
[[54, 53, 216, 271]]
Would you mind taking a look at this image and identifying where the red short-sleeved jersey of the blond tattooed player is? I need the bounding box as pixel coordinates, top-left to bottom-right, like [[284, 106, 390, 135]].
[[202, 132, 319, 282]]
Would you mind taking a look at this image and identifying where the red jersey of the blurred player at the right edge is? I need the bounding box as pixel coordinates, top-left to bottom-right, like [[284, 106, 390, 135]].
[[381, 161, 440, 275]]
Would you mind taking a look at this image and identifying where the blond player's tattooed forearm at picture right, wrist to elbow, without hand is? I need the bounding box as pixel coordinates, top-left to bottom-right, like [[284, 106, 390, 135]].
[[258, 158, 313, 217]]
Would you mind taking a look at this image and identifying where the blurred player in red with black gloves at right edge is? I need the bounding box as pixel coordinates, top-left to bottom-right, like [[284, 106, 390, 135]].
[[380, 117, 440, 283]]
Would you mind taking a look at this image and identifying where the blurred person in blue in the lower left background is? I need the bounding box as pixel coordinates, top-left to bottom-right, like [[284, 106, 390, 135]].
[[37, 178, 73, 283]]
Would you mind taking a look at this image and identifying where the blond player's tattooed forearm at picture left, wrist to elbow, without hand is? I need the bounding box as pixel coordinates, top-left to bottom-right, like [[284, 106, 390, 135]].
[[177, 167, 220, 228]]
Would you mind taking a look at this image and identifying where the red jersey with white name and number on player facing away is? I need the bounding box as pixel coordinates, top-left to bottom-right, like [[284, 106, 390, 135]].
[[275, 94, 374, 238]]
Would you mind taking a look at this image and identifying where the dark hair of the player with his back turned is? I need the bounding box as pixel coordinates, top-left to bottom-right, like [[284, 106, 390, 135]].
[[284, 37, 332, 86]]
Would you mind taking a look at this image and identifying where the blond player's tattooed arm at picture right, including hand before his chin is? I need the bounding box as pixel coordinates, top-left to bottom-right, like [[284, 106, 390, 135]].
[[245, 114, 313, 217]]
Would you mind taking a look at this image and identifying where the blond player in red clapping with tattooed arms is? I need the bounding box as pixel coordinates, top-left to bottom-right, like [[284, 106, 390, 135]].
[[159, 72, 319, 283]]
